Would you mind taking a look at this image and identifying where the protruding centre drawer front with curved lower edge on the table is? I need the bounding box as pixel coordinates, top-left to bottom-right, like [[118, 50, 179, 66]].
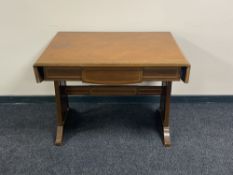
[[82, 68, 143, 84]]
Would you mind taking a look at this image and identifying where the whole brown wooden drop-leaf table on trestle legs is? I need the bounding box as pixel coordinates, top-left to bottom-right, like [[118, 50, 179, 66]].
[[34, 32, 190, 146]]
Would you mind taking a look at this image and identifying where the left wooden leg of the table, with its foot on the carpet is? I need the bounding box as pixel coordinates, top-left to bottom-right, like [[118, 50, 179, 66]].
[[54, 81, 69, 145]]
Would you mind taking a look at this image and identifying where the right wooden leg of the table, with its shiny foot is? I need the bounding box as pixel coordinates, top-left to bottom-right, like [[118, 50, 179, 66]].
[[160, 82, 172, 147]]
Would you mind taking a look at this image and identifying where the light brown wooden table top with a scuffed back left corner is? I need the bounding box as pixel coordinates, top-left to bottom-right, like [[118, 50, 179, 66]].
[[34, 32, 190, 67]]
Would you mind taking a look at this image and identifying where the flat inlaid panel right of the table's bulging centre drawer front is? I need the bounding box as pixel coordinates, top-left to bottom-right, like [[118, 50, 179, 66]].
[[143, 67, 180, 81]]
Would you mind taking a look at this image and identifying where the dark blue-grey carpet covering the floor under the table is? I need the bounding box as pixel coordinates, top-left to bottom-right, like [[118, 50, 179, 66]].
[[0, 103, 233, 175]]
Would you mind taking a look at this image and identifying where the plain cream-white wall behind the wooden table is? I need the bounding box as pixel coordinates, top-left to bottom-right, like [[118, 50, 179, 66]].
[[0, 0, 233, 95]]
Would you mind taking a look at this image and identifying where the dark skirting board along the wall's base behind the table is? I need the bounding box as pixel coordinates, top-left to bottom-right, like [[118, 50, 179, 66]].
[[0, 95, 233, 103]]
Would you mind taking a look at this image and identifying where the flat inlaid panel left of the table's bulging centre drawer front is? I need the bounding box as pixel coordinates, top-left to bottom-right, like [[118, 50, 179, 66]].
[[44, 67, 82, 80]]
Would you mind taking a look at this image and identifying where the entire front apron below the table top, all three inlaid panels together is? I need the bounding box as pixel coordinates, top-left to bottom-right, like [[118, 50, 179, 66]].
[[44, 67, 181, 84]]
